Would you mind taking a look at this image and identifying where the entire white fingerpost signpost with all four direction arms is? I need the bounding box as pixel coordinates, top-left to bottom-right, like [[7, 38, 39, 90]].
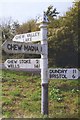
[[2, 13, 79, 115]]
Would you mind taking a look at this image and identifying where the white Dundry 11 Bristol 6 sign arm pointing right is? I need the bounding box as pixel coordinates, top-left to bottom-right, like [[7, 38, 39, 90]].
[[48, 68, 78, 79]]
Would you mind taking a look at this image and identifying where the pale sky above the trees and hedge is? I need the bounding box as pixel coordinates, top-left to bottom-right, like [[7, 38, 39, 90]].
[[0, 0, 73, 23]]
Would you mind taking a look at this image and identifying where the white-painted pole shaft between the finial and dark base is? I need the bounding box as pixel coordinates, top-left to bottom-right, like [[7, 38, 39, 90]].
[[39, 22, 48, 84]]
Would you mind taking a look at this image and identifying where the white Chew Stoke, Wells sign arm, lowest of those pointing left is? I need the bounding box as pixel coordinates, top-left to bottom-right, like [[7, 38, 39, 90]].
[[4, 59, 41, 69]]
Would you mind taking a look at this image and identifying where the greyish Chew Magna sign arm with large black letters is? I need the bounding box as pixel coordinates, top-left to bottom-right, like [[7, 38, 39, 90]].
[[2, 41, 44, 54]]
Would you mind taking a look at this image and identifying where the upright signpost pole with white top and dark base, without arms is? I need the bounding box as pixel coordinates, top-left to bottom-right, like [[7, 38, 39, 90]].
[[37, 12, 48, 115]]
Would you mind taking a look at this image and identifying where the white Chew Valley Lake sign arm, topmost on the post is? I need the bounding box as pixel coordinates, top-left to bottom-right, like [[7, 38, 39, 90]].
[[13, 31, 41, 42]]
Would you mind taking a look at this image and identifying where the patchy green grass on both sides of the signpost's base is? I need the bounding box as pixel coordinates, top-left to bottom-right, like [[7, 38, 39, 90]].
[[0, 70, 80, 118]]
